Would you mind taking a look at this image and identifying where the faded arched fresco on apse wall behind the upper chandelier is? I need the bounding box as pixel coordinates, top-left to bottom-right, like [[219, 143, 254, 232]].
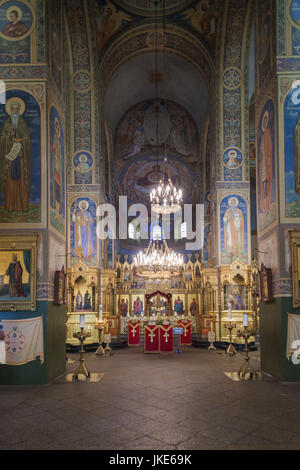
[[114, 100, 199, 204]]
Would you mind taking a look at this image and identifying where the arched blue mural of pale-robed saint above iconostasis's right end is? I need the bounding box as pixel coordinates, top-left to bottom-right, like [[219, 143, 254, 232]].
[[220, 195, 248, 264]]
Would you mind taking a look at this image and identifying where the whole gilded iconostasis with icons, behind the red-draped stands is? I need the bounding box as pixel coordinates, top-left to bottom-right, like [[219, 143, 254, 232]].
[[67, 254, 255, 345]]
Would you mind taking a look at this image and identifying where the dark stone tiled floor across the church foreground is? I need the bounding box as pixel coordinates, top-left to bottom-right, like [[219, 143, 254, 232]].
[[0, 349, 300, 450]]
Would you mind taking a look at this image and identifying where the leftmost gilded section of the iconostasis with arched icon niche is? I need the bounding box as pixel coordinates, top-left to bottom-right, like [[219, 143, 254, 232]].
[[67, 262, 99, 346]]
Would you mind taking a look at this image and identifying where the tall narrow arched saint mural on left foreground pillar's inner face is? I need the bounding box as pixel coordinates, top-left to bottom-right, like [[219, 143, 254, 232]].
[[50, 107, 66, 235]]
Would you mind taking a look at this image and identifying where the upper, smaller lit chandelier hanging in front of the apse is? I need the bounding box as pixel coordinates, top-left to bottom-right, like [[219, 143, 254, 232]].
[[150, 179, 183, 214]]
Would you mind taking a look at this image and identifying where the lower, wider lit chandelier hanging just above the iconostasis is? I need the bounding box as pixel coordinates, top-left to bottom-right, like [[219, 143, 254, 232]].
[[133, 240, 183, 278]]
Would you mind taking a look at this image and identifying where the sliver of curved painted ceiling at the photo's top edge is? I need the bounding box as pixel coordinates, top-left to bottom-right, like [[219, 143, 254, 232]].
[[115, 0, 193, 16]]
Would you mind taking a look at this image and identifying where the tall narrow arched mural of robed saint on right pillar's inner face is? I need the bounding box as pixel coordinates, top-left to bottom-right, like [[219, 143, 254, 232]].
[[257, 100, 276, 232]]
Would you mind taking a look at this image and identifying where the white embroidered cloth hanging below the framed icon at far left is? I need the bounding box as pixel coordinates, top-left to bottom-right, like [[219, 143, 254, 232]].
[[2, 317, 44, 366]]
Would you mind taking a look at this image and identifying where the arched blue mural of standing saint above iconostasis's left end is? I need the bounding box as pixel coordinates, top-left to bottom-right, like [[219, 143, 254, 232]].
[[70, 197, 97, 266]]
